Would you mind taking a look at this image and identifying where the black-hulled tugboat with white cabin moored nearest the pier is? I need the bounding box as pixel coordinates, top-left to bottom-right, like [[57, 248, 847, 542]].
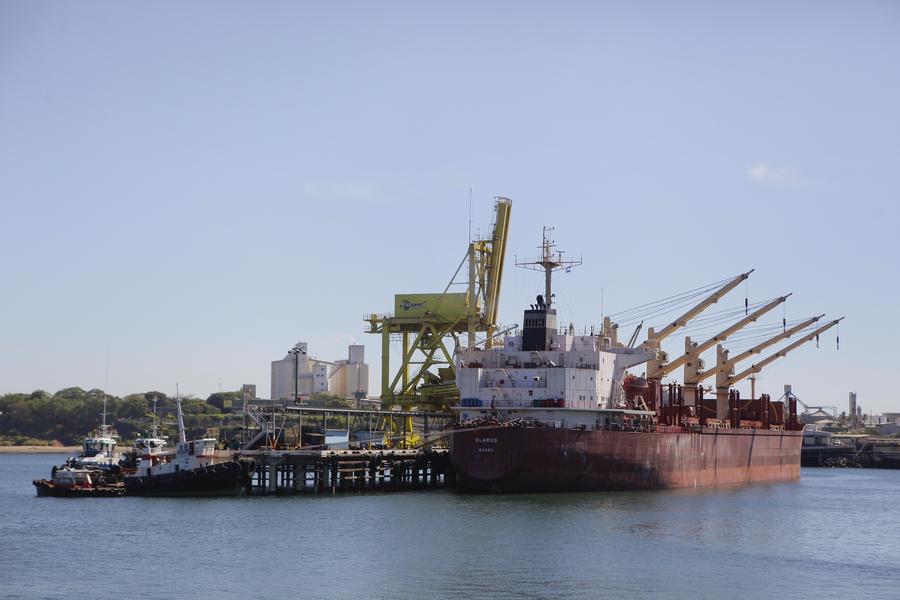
[[125, 394, 249, 496]]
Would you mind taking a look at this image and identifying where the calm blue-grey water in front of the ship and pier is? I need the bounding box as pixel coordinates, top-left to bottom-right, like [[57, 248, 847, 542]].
[[0, 454, 900, 600]]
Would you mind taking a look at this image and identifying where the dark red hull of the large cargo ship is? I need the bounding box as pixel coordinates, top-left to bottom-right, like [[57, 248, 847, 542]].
[[450, 427, 803, 493]]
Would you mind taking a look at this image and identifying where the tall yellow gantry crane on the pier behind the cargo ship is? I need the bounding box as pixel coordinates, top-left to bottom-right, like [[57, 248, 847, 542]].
[[365, 197, 512, 412]]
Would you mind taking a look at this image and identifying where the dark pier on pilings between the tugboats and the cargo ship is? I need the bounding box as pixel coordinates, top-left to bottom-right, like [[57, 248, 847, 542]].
[[240, 401, 455, 495]]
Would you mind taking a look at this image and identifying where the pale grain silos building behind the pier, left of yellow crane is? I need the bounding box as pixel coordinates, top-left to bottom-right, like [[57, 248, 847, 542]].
[[271, 342, 369, 400]]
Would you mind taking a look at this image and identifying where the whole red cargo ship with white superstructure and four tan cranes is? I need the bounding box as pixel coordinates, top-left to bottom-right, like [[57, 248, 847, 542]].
[[450, 228, 840, 493]]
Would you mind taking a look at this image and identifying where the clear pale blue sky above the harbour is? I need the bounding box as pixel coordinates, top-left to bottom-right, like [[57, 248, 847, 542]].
[[0, 0, 900, 418]]
